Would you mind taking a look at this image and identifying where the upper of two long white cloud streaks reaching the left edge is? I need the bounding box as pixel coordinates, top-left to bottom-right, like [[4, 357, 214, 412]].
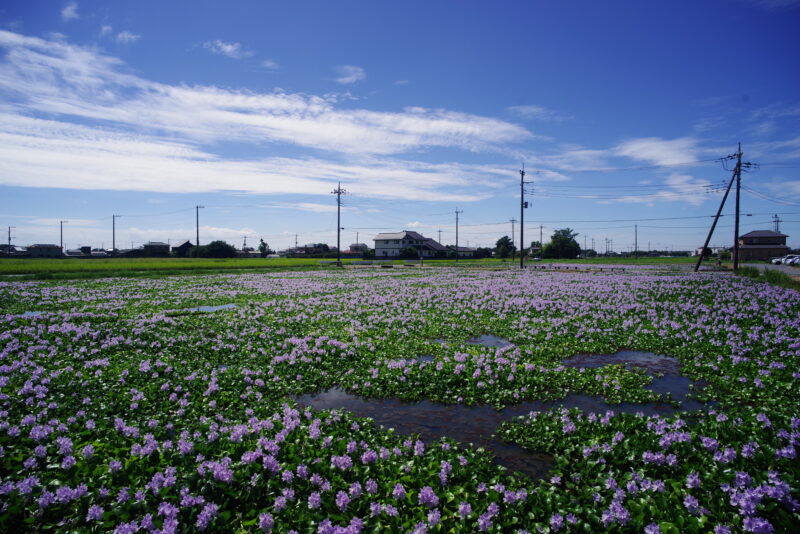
[[0, 32, 533, 155]]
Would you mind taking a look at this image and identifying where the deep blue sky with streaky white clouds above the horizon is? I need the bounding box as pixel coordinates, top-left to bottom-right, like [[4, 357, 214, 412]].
[[0, 0, 800, 251]]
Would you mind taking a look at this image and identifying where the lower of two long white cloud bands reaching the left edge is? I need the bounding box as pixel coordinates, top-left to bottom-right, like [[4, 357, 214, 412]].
[[0, 113, 500, 203]]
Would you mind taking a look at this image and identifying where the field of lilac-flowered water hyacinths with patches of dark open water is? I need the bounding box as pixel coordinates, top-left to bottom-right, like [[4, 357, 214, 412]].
[[0, 268, 800, 534]]
